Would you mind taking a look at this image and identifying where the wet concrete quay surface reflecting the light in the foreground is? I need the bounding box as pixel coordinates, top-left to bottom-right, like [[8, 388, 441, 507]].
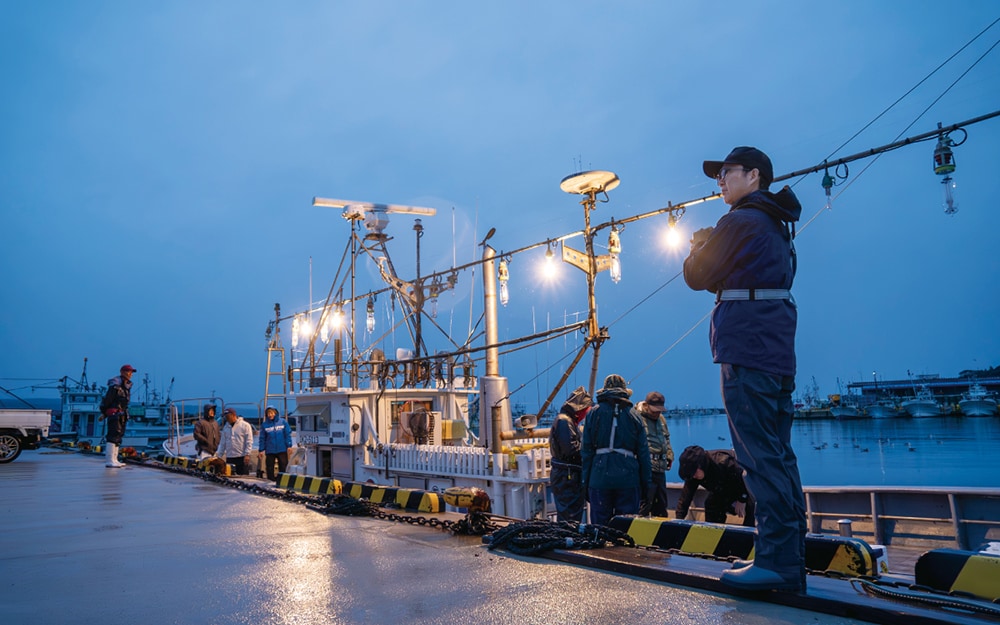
[[0, 449, 996, 625]]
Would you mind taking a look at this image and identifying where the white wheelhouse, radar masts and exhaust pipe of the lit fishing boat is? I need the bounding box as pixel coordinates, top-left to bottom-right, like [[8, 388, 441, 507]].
[[264, 171, 648, 518]]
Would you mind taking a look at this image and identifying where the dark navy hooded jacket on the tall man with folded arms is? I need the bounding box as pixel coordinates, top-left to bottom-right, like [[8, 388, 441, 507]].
[[684, 186, 802, 375]]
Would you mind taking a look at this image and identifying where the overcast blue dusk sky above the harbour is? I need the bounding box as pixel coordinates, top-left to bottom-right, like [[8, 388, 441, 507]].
[[0, 0, 1000, 406]]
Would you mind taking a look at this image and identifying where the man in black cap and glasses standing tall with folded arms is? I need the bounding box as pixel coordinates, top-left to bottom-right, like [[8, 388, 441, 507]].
[[684, 146, 806, 591]]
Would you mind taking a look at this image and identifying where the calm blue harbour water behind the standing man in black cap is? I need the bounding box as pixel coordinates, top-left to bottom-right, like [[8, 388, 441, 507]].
[[667, 414, 1000, 487]]
